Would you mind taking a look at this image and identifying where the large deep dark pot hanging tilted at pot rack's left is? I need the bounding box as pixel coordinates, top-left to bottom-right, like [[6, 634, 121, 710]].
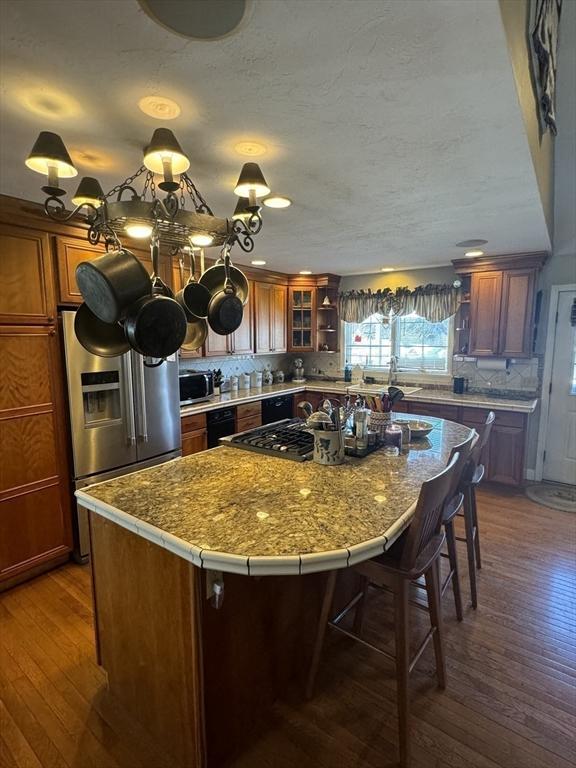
[[76, 248, 151, 323]]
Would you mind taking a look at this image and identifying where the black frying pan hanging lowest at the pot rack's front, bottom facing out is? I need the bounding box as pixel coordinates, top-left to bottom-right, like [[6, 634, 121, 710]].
[[124, 242, 187, 358]]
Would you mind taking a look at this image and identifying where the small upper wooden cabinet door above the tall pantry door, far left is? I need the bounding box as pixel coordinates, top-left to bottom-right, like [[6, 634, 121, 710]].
[[0, 224, 56, 325]]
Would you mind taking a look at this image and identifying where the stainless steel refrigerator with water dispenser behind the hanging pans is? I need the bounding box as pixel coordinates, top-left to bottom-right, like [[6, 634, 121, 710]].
[[62, 312, 181, 562]]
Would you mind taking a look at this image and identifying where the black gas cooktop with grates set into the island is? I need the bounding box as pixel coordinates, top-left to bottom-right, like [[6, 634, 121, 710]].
[[220, 419, 314, 461]]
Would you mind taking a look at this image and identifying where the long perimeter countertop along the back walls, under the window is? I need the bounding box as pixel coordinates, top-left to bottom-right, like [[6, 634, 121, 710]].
[[180, 380, 538, 416]]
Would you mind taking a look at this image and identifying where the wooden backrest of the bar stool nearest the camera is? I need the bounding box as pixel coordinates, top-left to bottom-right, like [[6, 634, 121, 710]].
[[401, 453, 460, 570]]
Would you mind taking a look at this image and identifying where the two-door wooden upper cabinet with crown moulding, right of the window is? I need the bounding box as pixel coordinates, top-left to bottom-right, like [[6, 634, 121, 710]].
[[453, 253, 546, 357]]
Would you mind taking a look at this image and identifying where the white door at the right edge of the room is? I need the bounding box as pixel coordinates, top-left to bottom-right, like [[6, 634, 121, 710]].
[[543, 290, 576, 485]]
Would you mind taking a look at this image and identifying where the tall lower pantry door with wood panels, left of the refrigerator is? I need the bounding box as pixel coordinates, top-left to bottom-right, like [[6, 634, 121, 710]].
[[0, 325, 72, 589]]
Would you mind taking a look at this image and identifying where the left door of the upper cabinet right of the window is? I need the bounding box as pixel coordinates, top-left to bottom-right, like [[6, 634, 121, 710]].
[[469, 272, 502, 357]]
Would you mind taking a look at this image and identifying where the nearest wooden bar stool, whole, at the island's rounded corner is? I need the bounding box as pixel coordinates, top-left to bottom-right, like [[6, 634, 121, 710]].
[[306, 453, 464, 768]]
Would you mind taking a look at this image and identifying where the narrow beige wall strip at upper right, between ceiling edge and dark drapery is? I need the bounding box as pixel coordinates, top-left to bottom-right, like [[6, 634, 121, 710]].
[[500, 0, 552, 239]]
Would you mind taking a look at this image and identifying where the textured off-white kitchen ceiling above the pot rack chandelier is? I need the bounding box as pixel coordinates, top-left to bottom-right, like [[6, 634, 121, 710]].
[[0, 0, 550, 274]]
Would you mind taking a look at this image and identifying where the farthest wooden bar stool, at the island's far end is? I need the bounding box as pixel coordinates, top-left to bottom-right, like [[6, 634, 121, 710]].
[[456, 411, 496, 608]]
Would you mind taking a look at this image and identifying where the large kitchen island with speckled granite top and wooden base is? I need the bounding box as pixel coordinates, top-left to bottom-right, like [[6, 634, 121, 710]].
[[77, 419, 470, 768]]
